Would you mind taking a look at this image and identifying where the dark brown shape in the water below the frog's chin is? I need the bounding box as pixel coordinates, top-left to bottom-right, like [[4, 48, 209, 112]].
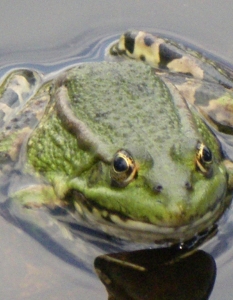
[[95, 248, 216, 300]]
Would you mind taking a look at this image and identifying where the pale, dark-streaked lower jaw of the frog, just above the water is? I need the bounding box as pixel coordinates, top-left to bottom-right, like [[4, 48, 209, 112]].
[[69, 191, 228, 243]]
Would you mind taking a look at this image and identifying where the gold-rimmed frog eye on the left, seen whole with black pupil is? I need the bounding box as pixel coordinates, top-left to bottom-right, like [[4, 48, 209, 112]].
[[110, 149, 137, 187]]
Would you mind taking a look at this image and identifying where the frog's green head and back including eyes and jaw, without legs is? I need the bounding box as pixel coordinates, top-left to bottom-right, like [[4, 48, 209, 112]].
[[28, 62, 228, 242]]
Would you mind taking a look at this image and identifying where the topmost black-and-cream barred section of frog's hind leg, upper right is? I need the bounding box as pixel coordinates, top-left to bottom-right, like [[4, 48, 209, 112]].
[[110, 31, 233, 88]]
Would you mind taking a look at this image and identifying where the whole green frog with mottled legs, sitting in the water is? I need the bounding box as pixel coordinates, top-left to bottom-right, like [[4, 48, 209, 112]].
[[0, 31, 233, 244]]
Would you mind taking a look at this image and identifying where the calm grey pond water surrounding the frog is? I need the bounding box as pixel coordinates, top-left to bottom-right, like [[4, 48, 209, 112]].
[[0, 0, 233, 300]]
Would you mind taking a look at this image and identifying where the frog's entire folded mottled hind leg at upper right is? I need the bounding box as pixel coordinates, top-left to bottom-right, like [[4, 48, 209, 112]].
[[110, 31, 233, 134]]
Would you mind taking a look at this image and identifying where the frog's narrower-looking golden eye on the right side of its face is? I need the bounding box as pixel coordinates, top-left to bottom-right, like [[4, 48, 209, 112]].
[[196, 142, 213, 174]]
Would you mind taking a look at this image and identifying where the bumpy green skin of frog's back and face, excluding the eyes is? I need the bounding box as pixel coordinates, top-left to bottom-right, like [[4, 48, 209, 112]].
[[28, 62, 227, 241]]
